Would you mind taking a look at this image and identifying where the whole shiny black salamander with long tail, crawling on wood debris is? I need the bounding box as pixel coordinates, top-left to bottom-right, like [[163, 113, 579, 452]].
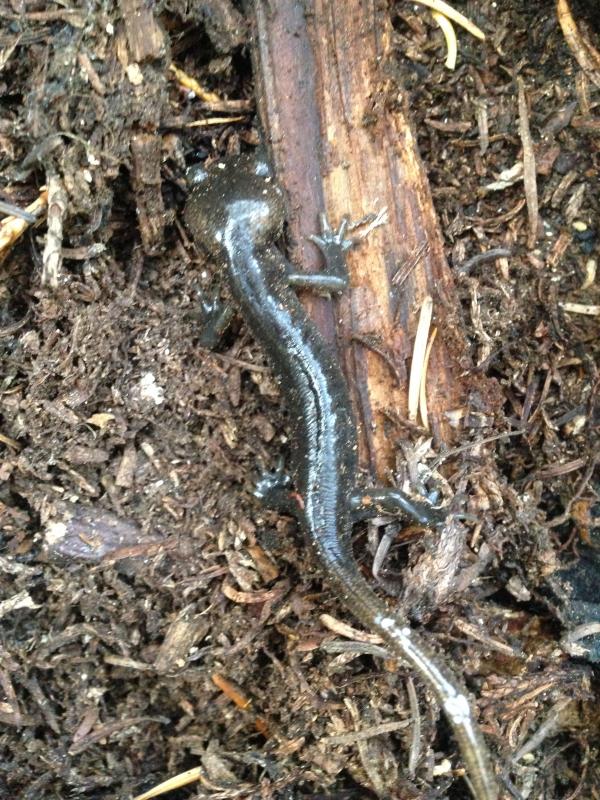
[[185, 156, 498, 800]]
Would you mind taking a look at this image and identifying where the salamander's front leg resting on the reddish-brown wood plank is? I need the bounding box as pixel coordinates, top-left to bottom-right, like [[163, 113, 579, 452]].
[[288, 214, 354, 294]]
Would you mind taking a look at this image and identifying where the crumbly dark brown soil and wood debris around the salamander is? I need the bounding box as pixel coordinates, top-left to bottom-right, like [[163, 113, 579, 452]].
[[0, 0, 600, 800]]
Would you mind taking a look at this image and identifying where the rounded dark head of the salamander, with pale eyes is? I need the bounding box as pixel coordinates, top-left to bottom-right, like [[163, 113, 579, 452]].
[[184, 155, 284, 255]]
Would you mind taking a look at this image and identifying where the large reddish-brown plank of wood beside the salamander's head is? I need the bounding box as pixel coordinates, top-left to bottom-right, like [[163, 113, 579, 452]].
[[254, 0, 464, 477]]
